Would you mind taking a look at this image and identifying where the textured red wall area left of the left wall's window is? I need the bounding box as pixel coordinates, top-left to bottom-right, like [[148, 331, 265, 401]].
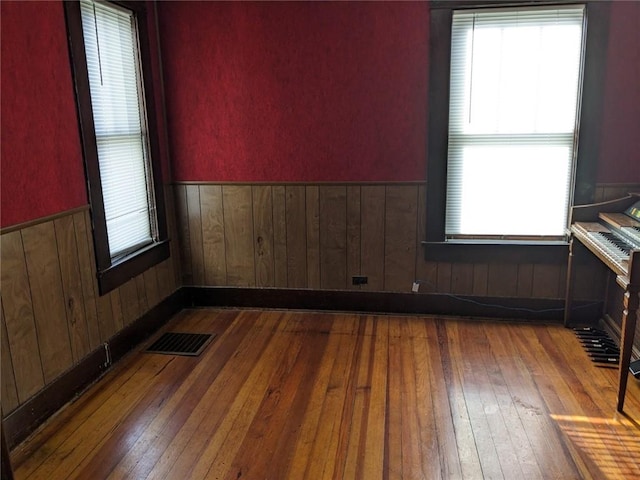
[[0, 1, 87, 227]]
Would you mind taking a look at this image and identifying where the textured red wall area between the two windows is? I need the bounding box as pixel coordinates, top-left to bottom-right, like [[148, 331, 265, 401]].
[[158, 2, 429, 181]]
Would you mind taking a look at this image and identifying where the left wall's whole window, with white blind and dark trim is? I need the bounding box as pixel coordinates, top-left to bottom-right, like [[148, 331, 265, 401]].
[[65, 0, 169, 293]]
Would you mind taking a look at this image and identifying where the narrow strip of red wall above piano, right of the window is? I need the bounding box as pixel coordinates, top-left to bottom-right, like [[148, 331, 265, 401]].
[[598, 1, 640, 183]]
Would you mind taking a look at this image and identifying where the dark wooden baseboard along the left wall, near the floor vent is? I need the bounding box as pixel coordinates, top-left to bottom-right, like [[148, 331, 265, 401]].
[[3, 289, 185, 450]]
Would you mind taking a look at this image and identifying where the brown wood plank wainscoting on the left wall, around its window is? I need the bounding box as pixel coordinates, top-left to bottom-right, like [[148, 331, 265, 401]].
[[0, 189, 181, 415]]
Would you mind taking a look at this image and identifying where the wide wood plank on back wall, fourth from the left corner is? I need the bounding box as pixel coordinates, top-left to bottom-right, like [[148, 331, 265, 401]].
[[222, 185, 256, 287]]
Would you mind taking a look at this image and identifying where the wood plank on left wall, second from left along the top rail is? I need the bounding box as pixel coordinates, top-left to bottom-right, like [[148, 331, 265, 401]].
[[22, 222, 73, 382]]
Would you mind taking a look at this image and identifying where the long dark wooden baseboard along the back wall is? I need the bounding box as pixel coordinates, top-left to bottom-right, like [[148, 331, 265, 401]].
[[183, 287, 602, 324]]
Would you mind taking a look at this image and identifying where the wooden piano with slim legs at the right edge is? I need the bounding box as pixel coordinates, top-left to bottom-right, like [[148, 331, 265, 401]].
[[564, 194, 640, 412]]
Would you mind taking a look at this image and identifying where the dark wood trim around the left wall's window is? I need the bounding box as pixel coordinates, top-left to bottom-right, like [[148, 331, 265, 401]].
[[64, 1, 169, 294]]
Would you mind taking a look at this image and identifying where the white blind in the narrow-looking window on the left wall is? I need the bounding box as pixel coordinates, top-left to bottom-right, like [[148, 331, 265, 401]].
[[81, 1, 155, 258]]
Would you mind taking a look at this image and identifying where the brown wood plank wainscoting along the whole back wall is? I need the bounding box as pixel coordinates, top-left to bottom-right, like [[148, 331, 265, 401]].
[[174, 183, 640, 298]]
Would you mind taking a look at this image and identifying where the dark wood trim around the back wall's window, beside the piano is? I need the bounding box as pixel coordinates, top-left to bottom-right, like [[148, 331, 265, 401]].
[[422, 0, 609, 263]]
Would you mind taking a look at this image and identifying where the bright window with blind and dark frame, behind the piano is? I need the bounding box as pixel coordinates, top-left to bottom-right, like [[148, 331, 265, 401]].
[[425, 1, 608, 262]]
